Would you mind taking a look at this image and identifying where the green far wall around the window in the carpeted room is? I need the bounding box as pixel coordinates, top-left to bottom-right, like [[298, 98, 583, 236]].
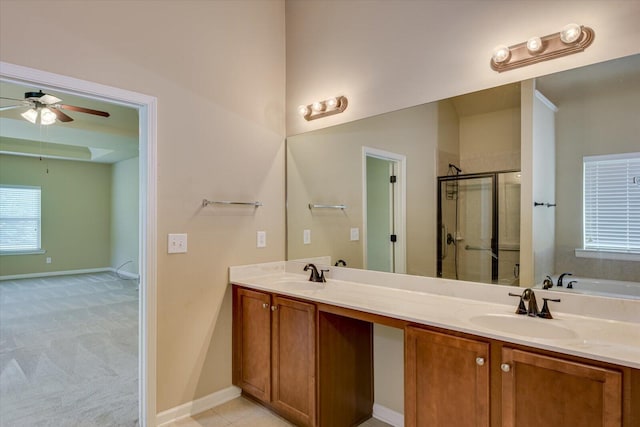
[[0, 154, 111, 276]]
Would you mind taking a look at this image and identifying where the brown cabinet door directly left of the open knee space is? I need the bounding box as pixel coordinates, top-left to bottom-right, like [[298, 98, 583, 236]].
[[271, 296, 316, 426]]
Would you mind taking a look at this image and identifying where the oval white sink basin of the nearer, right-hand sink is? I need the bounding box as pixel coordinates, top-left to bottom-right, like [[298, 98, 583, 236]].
[[469, 314, 577, 340]]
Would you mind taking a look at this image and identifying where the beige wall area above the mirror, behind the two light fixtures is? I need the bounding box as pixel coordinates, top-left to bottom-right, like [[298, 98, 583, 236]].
[[286, 0, 640, 135]]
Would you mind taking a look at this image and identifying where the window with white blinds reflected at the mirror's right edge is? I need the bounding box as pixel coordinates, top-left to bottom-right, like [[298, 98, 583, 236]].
[[583, 153, 640, 254]]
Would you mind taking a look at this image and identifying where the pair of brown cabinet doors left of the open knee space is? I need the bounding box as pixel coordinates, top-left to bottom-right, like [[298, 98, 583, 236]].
[[233, 286, 317, 427]]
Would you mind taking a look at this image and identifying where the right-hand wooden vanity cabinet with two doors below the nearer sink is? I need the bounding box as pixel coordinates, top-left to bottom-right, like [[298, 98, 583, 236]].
[[405, 326, 640, 427]]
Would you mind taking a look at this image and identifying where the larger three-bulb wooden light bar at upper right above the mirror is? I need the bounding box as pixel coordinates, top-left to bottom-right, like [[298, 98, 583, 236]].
[[491, 24, 595, 73]]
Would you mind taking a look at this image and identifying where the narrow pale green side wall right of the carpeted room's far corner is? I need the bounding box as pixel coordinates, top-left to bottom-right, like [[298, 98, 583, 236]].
[[111, 157, 140, 274]]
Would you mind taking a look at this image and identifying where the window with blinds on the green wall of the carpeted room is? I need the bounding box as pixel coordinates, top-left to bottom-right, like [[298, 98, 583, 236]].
[[0, 185, 41, 253]]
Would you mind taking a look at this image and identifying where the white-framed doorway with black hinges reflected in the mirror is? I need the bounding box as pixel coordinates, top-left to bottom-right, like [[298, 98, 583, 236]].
[[362, 147, 406, 273]]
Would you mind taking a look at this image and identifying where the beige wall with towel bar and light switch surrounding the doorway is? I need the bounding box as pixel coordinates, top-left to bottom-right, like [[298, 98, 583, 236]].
[[0, 0, 285, 411]]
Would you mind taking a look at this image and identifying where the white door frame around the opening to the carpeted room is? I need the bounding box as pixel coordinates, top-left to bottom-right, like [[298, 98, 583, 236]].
[[0, 61, 157, 427]]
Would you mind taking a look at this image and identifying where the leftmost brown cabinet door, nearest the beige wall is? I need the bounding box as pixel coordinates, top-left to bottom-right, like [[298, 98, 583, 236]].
[[233, 288, 271, 402]]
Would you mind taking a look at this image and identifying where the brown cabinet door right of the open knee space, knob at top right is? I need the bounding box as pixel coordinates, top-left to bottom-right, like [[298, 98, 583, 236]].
[[405, 327, 489, 427]]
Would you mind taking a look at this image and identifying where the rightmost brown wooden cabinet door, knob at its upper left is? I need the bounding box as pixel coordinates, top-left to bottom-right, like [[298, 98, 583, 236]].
[[502, 348, 622, 427]]
